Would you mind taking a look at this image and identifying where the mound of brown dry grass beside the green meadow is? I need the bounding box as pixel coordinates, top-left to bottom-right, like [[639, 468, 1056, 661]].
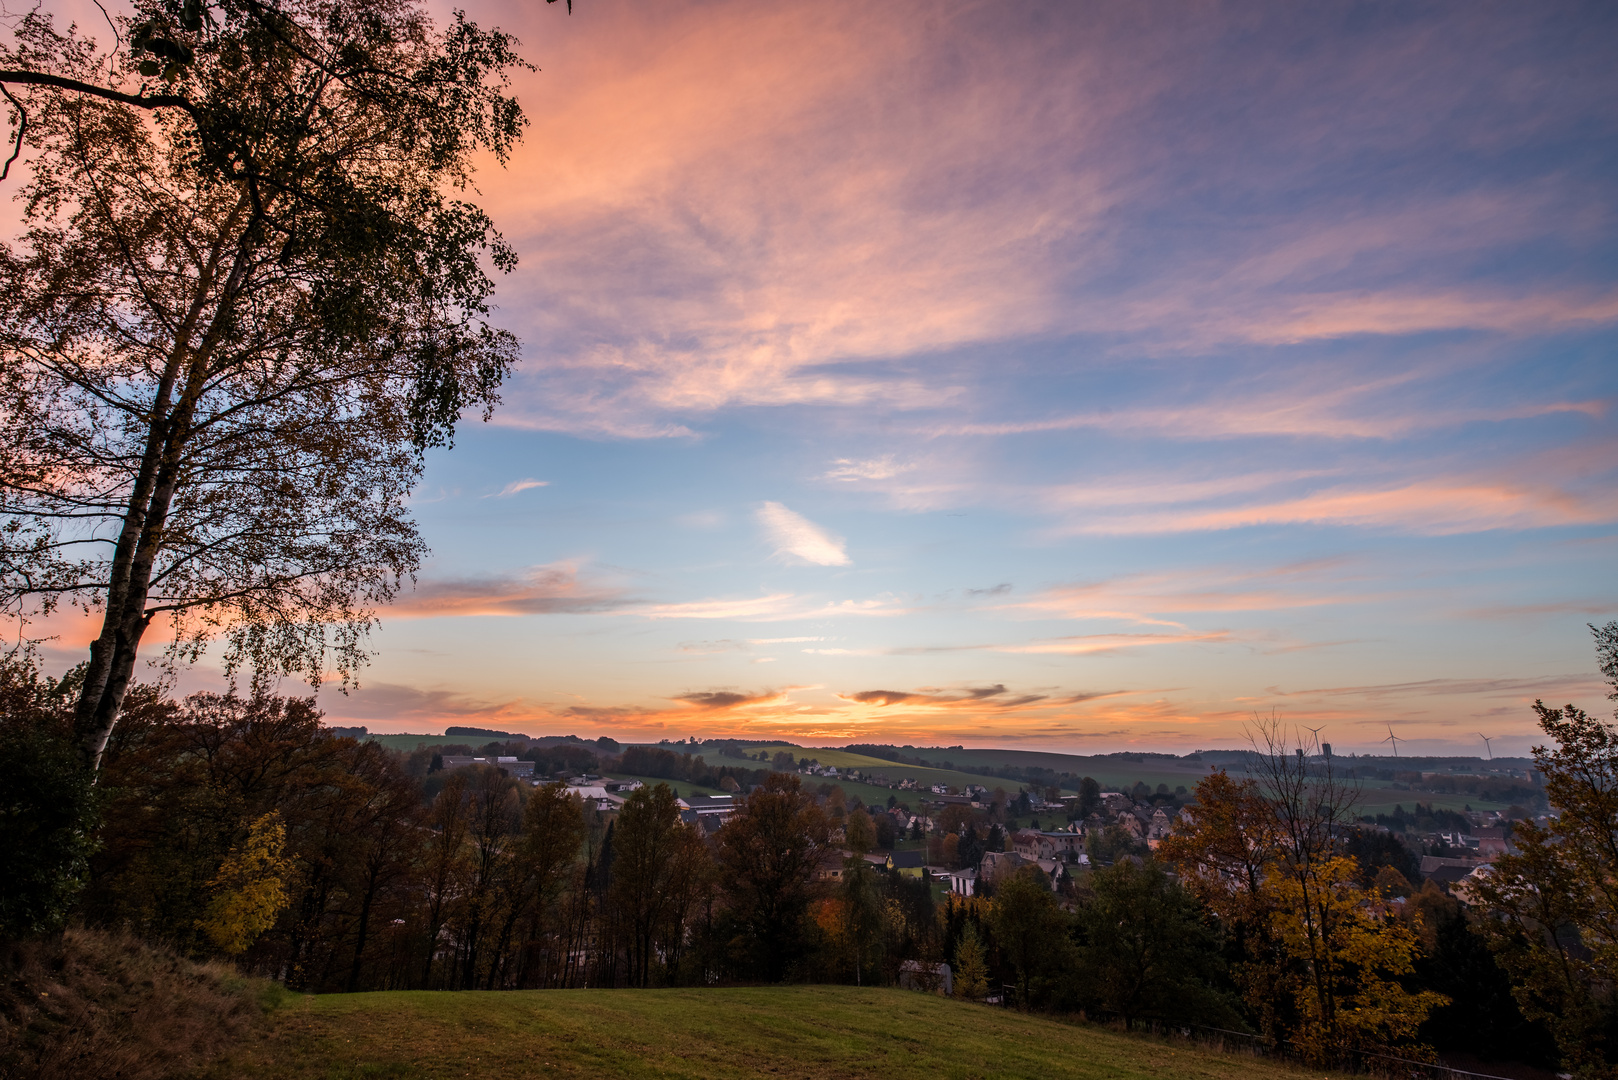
[[0, 929, 270, 1080]]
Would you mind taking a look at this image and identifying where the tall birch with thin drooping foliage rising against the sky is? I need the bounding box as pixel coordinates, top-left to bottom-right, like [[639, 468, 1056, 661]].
[[0, 0, 523, 761]]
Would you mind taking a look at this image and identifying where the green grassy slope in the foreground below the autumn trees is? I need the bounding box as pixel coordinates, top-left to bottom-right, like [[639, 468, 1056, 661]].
[[205, 986, 1339, 1080]]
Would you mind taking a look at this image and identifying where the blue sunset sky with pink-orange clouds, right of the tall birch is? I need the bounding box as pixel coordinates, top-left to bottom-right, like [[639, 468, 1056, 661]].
[[19, 0, 1618, 755]]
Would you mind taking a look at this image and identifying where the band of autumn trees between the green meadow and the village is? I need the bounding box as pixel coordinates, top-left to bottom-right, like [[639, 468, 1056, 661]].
[[0, 623, 1618, 1077]]
